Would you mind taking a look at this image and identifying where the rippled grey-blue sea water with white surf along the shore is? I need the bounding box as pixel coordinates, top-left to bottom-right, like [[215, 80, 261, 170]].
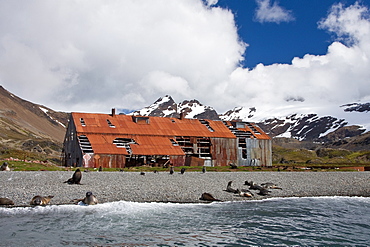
[[0, 197, 370, 246]]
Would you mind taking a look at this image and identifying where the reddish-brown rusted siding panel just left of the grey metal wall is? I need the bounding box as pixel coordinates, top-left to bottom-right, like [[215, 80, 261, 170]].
[[211, 138, 237, 166]]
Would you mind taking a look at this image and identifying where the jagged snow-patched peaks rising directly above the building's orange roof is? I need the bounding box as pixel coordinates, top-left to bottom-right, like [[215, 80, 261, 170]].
[[132, 95, 219, 120]]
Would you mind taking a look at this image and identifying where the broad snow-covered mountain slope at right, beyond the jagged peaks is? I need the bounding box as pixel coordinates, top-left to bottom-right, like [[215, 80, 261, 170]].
[[220, 103, 370, 141]]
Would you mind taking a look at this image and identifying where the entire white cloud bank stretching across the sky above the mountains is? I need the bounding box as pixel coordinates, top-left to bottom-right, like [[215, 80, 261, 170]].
[[0, 0, 370, 117]]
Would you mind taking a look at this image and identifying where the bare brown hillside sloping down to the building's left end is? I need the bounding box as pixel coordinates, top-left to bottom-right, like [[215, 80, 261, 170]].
[[0, 86, 69, 153]]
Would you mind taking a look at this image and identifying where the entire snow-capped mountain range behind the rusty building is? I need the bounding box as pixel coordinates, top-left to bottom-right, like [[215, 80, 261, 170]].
[[132, 95, 370, 149]]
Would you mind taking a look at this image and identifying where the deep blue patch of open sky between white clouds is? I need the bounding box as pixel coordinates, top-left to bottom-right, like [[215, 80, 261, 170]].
[[216, 0, 364, 68]]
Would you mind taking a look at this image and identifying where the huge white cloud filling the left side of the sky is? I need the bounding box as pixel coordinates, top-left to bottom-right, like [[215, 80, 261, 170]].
[[0, 0, 245, 111]]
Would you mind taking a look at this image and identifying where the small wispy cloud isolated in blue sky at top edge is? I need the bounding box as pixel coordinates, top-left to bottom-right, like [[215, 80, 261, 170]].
[[255, 0, 294, 23]]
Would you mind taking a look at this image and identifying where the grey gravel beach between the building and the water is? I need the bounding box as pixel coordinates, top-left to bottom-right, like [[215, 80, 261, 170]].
[[0, 171, 370, 206]]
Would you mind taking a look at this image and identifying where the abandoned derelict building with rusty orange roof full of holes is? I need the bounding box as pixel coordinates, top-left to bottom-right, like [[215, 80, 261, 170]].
[[63, 109, 272, 168]]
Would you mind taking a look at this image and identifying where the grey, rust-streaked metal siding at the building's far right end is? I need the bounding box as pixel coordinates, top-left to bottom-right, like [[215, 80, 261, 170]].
[[237, 138, 272, 166]]
